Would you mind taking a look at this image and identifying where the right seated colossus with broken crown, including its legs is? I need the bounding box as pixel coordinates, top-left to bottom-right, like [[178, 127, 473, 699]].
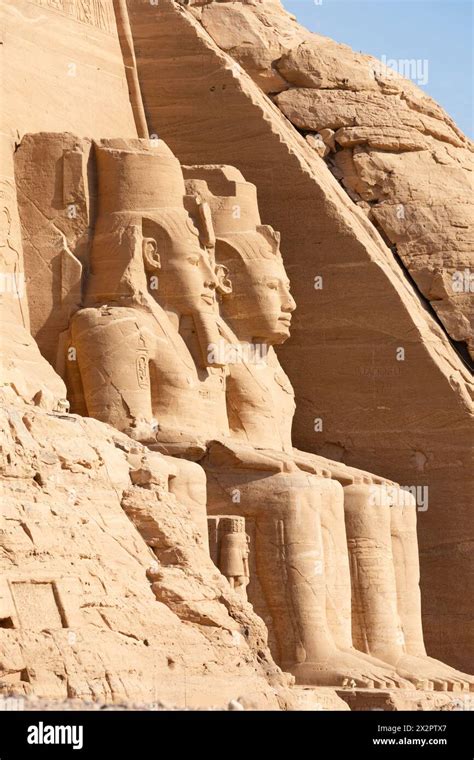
[[185, 167, 474, 690]]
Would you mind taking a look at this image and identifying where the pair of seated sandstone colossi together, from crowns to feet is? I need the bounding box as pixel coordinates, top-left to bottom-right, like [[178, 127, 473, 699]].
[[66, 140, 466, 689]]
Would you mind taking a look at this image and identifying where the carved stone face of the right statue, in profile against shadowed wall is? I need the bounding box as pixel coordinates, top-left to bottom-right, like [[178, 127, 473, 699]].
[[217, 227, 296, 344]]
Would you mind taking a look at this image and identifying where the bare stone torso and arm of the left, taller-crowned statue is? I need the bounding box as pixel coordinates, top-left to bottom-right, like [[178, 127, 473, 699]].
[[73, 305, 228, 441]]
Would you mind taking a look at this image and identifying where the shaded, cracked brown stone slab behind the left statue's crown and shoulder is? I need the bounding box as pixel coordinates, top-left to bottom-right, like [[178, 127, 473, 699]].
[[15, 132, 91, 366]]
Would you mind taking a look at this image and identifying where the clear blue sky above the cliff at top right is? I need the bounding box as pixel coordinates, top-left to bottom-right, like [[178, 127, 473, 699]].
[[282, 0, 474, 138]]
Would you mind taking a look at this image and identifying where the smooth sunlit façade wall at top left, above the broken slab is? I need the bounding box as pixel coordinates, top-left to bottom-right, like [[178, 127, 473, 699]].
[[0, 0, 136, 137]]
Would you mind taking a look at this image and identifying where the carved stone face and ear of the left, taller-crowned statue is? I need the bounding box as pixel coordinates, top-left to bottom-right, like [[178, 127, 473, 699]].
[[144, 214, 217, 314]]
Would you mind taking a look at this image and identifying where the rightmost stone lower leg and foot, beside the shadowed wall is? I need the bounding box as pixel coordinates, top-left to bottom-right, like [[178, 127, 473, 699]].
[[390, 489, 474, 691]]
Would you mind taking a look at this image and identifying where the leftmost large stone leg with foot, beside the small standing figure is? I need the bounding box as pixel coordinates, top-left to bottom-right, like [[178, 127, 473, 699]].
[[206, 466, 408, 688]]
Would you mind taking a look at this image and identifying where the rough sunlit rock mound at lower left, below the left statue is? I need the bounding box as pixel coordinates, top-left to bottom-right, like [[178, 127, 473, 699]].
[[0, 402, 294, 709]]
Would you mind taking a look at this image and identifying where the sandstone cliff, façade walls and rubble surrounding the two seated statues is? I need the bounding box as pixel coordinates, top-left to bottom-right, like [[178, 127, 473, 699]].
[[0, 0, 474, 709]]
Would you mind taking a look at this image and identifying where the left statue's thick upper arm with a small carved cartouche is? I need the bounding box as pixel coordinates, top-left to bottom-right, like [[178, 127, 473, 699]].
[[70, 307, 154, 440]]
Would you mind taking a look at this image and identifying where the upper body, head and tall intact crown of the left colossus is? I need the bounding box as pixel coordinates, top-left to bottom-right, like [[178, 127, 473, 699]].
[[65, 140, 227, 543]]
